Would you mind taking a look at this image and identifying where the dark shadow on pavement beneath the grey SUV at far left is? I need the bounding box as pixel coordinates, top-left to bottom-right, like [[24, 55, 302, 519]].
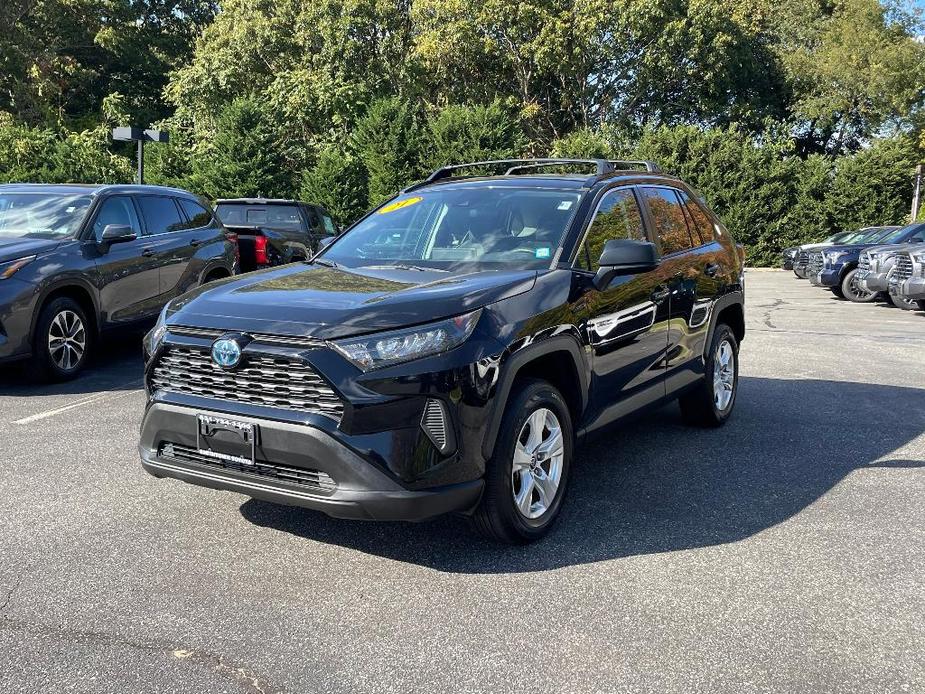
[[0, 331, 144, 396]]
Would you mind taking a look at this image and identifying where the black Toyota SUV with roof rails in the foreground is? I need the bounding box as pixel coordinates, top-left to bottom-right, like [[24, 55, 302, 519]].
[[140, 160, 745, 542]]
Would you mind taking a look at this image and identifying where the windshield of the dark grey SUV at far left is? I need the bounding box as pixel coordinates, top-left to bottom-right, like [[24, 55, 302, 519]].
[[0, 193, 92, 239]]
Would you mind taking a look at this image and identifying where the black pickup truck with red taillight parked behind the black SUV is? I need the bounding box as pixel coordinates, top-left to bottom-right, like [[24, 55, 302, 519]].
[[215, 198, 338, 272]]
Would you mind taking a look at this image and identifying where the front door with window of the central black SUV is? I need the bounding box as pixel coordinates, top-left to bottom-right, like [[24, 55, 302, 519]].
[[575, 187, 668, 428]]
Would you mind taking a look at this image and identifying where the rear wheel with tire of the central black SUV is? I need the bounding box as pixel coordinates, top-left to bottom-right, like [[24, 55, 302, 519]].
[[678, 323, 739, 427]]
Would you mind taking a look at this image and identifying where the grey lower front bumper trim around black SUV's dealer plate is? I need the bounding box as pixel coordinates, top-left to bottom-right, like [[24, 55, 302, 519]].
[[139, 402, 484, 521]]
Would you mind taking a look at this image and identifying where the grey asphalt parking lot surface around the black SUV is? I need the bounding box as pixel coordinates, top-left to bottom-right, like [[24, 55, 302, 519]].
[[0, 272, 925, 694]]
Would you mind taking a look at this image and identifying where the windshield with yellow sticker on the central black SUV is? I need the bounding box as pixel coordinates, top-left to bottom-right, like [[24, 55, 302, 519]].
[[322, 183, 581, 270]]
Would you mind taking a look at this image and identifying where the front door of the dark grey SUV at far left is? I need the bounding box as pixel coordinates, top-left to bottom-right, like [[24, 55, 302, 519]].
[[85, 195, 163, 324]]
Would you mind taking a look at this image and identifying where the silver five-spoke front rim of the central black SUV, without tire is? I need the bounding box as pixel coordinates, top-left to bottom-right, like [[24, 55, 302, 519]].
[[511, 407, 565, 520]]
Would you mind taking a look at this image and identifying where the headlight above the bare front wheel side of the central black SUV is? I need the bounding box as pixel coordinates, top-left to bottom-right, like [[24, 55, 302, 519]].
[[330, 309, 482, 371]]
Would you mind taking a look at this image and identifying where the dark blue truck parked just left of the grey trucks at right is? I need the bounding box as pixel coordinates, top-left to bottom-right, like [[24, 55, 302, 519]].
[[807, 225, 918, 303]]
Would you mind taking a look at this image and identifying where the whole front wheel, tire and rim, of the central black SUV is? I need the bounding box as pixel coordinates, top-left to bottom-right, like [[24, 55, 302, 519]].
[[473, 379, 574, 544]]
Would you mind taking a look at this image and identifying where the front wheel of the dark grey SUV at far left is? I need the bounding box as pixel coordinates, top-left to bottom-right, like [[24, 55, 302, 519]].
[[32, 297, 92, 381]]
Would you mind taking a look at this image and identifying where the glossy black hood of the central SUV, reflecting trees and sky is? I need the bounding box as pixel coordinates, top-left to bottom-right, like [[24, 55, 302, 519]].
[[168, 263, 537, 339]]
